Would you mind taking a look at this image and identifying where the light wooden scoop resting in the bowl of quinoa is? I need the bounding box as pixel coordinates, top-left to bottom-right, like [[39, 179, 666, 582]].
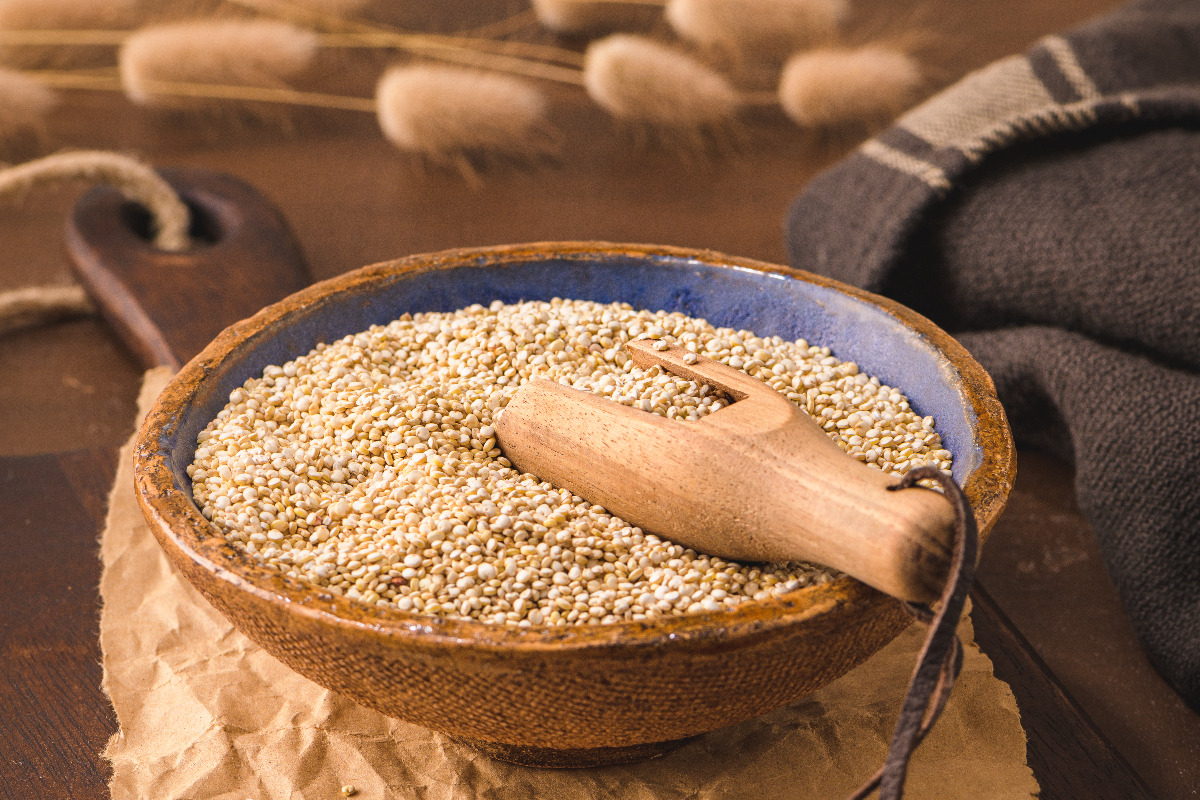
[[496, 339, 954, 602]]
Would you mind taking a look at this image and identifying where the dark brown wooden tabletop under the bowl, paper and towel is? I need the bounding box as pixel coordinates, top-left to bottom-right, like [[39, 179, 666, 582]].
[[0, 0, 1200, 800]]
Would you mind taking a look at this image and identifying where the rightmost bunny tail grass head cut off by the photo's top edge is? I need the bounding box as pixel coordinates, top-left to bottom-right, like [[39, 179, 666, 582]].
[[665, 0, 847, 64]]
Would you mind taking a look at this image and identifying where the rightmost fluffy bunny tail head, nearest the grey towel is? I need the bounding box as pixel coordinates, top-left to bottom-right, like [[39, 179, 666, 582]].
[[779, 44, 925, 128]]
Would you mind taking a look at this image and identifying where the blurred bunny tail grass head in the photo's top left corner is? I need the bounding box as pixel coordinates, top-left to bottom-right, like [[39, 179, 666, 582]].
[[0, 0, 140, 68]]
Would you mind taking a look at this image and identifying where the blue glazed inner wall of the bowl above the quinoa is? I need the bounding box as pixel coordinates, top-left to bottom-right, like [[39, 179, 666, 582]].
[[163, 253, 983, 489]]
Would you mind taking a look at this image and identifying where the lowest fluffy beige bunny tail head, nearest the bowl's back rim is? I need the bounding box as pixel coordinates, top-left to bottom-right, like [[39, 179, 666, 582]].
[[376, 65, 557, 175]]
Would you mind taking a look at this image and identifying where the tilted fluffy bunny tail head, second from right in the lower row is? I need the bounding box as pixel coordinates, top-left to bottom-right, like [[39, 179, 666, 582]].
[[583, 34, 740, 130]]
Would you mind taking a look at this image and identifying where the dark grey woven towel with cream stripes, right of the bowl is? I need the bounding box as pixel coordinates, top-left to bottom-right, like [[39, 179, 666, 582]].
[[786, 0, 1200, 708]]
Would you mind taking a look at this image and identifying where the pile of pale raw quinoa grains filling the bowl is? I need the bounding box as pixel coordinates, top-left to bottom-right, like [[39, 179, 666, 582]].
[[187, 299, 950, 626]]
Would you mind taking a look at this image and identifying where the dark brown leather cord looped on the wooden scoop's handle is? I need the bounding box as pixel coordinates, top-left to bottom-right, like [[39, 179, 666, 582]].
[[850, 467, 979, 800]]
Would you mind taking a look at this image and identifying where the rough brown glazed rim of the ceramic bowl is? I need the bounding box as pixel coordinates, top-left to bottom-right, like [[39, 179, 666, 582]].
[[134, 241, 1016, 656]]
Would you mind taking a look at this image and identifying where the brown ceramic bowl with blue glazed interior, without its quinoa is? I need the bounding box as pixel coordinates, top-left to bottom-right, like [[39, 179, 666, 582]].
[[136, 243, 1015, 766]]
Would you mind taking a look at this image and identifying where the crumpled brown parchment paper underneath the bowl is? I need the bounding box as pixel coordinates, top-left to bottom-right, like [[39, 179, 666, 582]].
[[101, 369, 1038, 800]]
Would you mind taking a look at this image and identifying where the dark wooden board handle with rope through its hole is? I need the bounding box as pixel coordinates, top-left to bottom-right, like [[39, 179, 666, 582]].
[[66, 167, 308, 369]]
